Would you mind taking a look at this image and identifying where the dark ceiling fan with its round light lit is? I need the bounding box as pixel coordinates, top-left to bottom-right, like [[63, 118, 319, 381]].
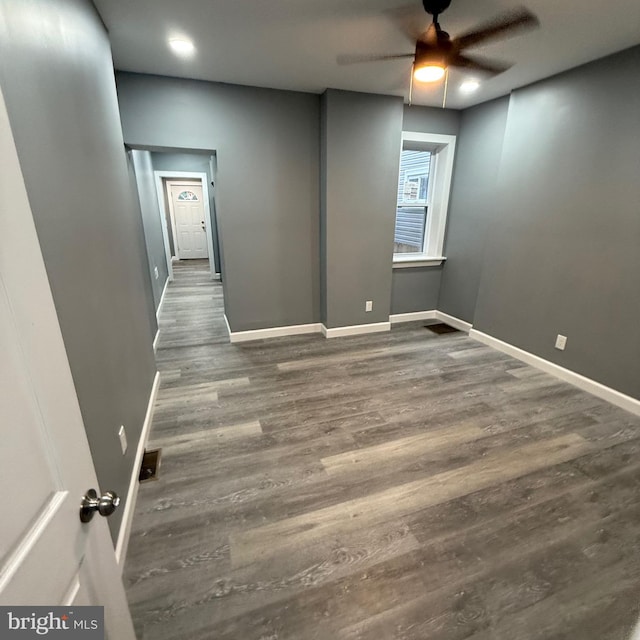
[[337, 0, 540, 82]]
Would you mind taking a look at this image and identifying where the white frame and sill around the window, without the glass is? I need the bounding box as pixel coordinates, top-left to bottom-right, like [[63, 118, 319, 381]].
[[393, 131, 456, 269]]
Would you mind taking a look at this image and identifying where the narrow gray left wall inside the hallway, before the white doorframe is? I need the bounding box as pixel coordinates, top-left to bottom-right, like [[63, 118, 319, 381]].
[[130, 150, 169, 311]]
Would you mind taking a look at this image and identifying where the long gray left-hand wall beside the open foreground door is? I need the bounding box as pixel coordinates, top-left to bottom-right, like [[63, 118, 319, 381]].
[[0, 0, 155, 534]]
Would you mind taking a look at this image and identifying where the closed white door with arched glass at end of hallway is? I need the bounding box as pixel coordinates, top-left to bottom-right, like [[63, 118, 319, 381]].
[[169, 182, 208, 260]]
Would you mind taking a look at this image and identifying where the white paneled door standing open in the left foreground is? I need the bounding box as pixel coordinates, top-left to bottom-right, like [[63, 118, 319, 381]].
[[0, 87, 135, 640]]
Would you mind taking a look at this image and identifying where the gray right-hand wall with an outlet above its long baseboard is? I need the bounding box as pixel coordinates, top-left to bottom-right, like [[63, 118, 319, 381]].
[[450, 47, 640, 398]]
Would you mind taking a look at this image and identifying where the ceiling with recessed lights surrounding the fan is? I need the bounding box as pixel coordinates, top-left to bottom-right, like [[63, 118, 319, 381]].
[[94, 0, 640, 109]]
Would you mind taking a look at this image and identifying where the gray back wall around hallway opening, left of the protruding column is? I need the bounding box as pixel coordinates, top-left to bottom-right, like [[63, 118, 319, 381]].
[[118, 73, 320, 331]]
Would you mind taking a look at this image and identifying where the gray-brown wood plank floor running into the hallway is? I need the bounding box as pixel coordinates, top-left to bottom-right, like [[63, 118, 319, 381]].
[[125, 263, 640, 640]]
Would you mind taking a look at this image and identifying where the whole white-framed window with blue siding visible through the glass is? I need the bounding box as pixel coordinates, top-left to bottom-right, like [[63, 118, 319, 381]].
[[393, 131, 456, 267]]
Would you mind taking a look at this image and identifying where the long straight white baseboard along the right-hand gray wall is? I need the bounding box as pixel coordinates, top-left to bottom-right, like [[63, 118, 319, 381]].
[[469, 329, 640, 415]]
